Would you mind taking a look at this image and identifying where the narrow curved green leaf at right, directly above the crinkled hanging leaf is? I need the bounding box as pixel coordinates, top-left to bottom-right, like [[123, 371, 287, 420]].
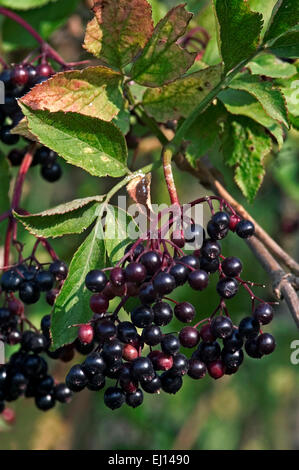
[[218, 88, 284, 148]]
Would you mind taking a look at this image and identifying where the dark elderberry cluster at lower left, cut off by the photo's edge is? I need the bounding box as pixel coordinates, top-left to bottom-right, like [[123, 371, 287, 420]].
[[0, 260, 72, 413]]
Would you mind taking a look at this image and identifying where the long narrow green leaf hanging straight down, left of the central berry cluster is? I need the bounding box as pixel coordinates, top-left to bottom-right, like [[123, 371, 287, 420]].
[[51, 217, 105, 350]]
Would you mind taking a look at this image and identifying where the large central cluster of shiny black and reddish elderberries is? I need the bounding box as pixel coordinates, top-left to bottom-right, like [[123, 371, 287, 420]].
[[62, 211, 275, 409]]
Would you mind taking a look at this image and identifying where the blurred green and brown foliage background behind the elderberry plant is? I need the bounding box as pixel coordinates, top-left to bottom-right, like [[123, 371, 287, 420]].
[[0, 0, 299, 450]]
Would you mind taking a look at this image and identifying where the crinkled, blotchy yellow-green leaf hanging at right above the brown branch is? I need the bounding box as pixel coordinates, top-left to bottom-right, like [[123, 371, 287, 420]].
[[223, 117, 272, 202]]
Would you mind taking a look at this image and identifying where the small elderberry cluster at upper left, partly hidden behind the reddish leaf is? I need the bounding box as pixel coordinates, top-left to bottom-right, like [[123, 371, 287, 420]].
[[0, 63, 62, 182]]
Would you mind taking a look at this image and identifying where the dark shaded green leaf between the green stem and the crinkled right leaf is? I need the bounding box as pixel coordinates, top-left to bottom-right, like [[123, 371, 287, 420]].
[[185, 102, 227, 168]]
